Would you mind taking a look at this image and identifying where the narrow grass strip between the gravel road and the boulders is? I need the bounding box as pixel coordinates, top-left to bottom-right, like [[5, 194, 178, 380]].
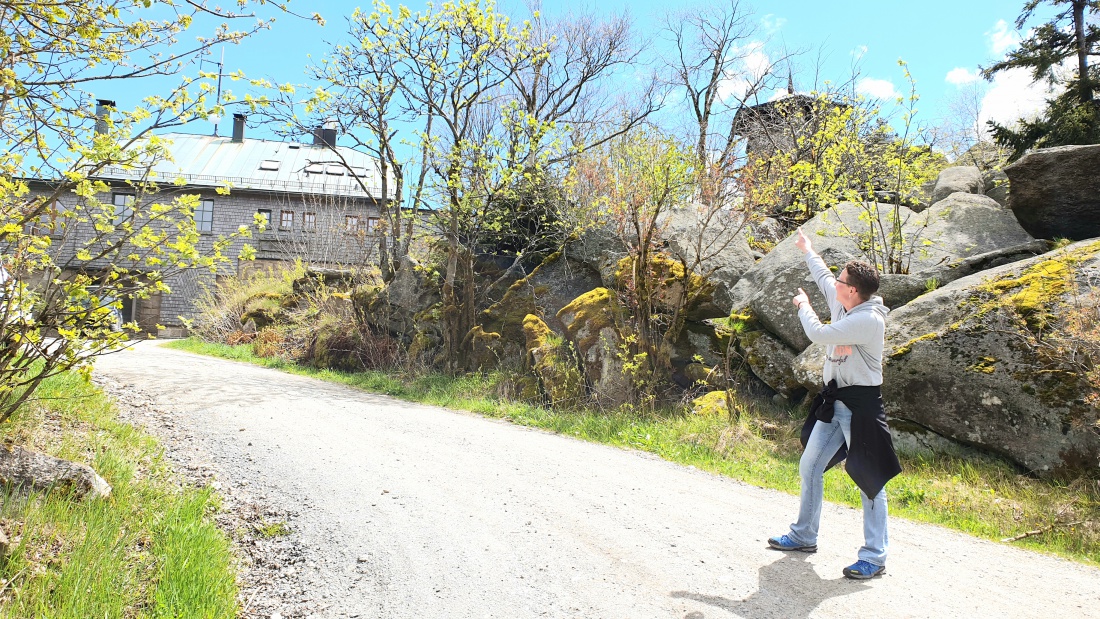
[[167, 339, 1100, 564]]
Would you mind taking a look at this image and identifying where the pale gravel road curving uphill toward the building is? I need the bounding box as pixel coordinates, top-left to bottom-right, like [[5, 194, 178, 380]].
[[96, 342, 1100, 619]]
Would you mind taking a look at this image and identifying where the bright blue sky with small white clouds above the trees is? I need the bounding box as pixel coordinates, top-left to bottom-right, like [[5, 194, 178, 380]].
[[95, 0, 1051, 144]]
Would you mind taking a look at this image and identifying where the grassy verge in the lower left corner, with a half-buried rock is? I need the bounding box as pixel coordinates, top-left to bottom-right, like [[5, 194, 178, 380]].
[[0, 367, 238, 619]]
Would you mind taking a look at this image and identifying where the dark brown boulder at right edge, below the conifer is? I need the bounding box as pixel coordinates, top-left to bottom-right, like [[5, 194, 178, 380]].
[[1004, 144, 1100, 241]]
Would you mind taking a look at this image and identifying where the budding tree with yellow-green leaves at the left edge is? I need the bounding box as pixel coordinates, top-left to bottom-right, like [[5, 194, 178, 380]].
[[0, 0, 310, 421]]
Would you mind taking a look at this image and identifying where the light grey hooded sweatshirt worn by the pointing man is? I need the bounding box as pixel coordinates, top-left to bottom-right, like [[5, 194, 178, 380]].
[[799, 252, 890, 387]]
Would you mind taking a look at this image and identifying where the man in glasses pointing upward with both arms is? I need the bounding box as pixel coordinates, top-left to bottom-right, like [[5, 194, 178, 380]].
[[768, 228, 901, 579]]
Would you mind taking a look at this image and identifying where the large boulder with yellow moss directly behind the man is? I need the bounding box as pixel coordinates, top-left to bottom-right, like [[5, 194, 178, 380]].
[[884, 240, 1100, 476]]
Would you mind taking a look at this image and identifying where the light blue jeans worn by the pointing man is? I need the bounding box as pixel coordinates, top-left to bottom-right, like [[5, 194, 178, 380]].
[[790, 400, 888, 565]]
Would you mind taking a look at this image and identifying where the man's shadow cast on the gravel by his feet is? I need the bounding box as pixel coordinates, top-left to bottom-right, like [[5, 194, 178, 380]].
[[670, 552, 869, 619]]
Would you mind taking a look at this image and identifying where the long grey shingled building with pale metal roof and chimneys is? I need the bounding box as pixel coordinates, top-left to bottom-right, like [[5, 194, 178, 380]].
[[23, 114, 393, 336]]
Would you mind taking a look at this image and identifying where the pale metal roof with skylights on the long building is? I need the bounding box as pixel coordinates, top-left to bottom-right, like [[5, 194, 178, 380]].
[[97, 133, 394, 198]]
